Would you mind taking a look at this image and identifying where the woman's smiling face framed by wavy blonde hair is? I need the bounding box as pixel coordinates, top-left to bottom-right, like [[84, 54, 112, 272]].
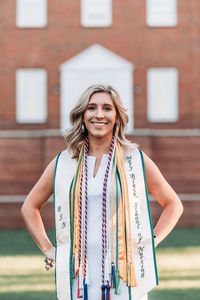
[[83, 92, 116, 138]]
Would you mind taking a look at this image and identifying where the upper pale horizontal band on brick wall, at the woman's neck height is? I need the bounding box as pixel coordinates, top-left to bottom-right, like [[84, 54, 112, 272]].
[[0, 128, 200, 139]]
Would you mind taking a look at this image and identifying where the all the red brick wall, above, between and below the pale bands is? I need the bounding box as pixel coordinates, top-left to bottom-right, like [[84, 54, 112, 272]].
[[0, 0, 200, 227]]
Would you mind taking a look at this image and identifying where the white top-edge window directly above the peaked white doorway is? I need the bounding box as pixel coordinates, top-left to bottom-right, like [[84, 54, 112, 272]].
[[81, 0, 112, 27]]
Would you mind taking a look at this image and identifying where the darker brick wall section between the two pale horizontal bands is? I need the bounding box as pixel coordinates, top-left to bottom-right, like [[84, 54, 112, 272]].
[[0, 136, 200, 195]]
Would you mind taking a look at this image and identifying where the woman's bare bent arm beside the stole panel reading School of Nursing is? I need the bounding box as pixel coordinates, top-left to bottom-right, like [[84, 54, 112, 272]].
[[143, 153, 183, 246]]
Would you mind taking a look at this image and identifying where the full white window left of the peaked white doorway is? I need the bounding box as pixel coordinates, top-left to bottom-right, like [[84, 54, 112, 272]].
[[16, 69, 47, 123]]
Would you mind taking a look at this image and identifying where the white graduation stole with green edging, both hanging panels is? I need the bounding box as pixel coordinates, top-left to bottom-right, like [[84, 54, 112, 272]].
[[54, 149, 158, 300]]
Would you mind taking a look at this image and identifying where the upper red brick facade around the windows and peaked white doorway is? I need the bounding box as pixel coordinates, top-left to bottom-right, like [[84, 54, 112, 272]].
[[0, 0, 200, 129]]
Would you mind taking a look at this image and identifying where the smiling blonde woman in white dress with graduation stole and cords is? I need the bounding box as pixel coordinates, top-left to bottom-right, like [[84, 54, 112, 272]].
[[22, 85, 183, 300]]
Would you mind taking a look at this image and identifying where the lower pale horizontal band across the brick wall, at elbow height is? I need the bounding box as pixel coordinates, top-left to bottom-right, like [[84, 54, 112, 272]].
[[0, 194, 200, 203]]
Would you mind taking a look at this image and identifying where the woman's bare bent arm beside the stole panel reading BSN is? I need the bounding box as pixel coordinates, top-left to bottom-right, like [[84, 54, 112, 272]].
[[21, 158, 56, 255]]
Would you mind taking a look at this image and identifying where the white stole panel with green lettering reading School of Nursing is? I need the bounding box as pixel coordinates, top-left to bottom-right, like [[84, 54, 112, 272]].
[[125, 149, 158, 300]]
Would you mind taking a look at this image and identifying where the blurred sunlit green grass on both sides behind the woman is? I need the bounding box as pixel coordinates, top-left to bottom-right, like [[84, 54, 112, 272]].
[[0, 228, 200, 300]]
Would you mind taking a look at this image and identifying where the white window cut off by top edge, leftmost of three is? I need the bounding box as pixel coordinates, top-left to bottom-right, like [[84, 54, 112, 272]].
[[16, 0, 47, 28]]
